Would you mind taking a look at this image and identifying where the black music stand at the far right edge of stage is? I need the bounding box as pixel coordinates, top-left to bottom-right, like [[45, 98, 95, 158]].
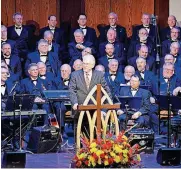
[[156, 95, 181, 148]]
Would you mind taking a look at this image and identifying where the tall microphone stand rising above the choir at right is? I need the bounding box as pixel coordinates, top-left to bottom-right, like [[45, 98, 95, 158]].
[[152, 15, 161, 134]]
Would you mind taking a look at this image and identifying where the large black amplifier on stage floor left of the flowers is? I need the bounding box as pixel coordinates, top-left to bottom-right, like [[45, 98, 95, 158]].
[[27, 126, 61, 153]]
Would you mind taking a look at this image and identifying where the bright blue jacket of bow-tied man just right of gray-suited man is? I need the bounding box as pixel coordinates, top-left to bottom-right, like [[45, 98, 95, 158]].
[[105, 72, 125, 97]]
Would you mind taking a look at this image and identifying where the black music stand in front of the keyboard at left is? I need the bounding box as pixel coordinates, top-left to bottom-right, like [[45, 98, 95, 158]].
[[5, 94, 35, 151]]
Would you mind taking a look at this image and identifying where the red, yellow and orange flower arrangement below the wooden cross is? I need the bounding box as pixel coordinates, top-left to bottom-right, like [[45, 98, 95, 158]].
[[73, 132, 141, 168]]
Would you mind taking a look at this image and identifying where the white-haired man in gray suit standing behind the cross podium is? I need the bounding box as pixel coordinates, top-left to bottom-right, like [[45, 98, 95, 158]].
[[69, 54, 112, 139]]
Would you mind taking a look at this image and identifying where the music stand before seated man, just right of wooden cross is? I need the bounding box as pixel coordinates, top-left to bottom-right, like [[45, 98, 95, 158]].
[[117, 96, 142, 125]]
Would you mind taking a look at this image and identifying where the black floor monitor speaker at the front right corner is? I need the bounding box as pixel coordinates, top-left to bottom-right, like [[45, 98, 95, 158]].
[[157, 148, 181, 165]]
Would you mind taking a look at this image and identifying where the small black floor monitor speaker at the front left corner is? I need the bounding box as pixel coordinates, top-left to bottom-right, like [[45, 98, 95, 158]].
[[2, 152, 26, 168]]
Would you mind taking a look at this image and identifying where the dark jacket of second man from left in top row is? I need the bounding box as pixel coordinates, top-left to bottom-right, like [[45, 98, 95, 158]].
[[40, 26, 65, 52]]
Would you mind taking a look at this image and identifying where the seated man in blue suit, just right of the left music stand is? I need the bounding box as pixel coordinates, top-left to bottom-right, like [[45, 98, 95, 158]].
[[20, 63, 51, 124]]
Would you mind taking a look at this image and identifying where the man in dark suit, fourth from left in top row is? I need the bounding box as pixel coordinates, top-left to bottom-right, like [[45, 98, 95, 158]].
[[99, 12, 127, 46]]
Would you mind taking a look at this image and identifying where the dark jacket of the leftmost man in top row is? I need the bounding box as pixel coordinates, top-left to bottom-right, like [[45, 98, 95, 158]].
[[7, 25, 30, 58]]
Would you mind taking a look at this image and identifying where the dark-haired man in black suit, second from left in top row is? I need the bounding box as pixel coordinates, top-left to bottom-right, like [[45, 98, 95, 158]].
[[40, 15, 65, 53]]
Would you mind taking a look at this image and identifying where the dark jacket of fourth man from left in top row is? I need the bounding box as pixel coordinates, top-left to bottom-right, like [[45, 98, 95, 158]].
[[99, 25, 127, 45]]
